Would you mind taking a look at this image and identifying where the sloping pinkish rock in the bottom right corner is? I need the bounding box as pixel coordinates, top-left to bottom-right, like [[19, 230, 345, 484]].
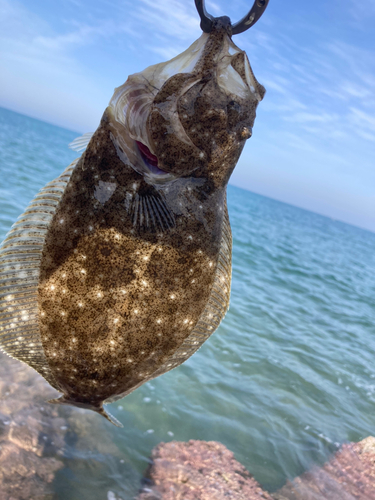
[[273, 436, 375, 500]]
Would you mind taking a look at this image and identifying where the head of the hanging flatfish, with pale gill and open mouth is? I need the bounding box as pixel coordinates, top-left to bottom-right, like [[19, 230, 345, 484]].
[[109, 18, 265, 186]]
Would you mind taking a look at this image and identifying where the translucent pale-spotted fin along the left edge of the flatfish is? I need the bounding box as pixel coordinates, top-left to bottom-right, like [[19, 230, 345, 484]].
[[0, 159, 78, 390]]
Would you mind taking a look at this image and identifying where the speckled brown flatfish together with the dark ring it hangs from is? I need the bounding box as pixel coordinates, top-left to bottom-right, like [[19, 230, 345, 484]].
[[0, 0, 268, 425]]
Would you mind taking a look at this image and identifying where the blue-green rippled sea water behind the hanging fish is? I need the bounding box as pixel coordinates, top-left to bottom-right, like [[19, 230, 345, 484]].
[[0, 104, 375, 500]]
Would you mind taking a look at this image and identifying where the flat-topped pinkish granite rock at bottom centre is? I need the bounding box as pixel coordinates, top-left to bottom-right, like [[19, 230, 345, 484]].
[[138, 441, 272, 500]]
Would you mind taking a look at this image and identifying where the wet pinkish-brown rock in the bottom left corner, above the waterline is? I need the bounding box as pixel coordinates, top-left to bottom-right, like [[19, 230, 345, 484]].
[[0, 353, 66, 500]]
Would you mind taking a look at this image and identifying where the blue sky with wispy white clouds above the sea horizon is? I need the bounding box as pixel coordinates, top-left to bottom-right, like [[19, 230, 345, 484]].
[[0, 0, 375, 231]]
